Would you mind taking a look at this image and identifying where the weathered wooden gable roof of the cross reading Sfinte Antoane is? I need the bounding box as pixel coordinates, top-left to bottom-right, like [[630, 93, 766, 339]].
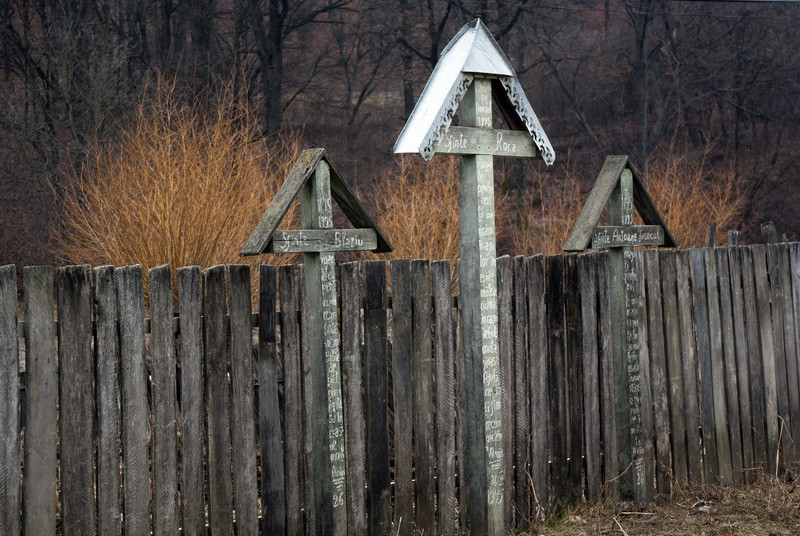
[[564, 155, 676, 251]]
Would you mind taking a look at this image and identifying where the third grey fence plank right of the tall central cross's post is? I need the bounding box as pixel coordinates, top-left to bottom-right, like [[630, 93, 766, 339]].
[[525, 255, 550, 519]]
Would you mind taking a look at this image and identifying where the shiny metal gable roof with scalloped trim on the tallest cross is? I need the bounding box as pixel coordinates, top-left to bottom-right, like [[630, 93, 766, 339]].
[[394, 19, 555, 165]]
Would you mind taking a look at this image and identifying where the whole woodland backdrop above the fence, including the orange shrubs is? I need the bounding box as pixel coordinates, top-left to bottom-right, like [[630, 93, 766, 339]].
[[0, 0, 800, 266]]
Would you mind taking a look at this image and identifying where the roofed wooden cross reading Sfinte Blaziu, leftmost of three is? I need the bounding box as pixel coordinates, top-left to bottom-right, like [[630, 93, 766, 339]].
[[240, 149, 392, 536]]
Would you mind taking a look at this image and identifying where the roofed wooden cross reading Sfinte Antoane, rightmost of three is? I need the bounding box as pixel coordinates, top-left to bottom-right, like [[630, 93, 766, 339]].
[[564, 156, 675, 505]]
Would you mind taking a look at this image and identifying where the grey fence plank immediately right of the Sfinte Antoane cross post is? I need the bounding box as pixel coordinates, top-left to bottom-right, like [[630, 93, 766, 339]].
[[643, 249, 674, 495]]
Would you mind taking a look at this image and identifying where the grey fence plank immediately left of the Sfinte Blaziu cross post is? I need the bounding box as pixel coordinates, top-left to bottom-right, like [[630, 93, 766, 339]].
[[279, 265, 310, 536]]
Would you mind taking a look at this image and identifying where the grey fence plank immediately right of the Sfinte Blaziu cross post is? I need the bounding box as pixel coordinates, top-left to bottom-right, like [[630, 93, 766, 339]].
[[341, 262, 370, 536]]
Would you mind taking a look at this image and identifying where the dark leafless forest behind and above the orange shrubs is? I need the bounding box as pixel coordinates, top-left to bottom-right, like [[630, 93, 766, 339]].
[[0, 0, 800, 265]]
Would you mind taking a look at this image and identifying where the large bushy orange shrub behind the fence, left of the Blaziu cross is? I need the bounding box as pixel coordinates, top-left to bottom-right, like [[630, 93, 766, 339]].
[[58, 75, 300, 269]]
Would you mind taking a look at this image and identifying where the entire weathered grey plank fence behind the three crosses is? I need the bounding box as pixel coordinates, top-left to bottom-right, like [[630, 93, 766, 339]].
[[0, 244, 800, 536]]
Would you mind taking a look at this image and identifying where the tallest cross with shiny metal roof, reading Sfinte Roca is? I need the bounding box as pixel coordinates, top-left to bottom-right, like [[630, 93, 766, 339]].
[[394, 20, 554, 534]]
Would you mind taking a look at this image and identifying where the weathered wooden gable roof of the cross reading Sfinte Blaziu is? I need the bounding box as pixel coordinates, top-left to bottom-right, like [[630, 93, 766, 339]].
[[239, 149, 392, 255]]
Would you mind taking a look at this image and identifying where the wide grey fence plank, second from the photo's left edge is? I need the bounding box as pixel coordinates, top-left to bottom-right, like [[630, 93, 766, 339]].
[[22, 266, 58, 536]]
